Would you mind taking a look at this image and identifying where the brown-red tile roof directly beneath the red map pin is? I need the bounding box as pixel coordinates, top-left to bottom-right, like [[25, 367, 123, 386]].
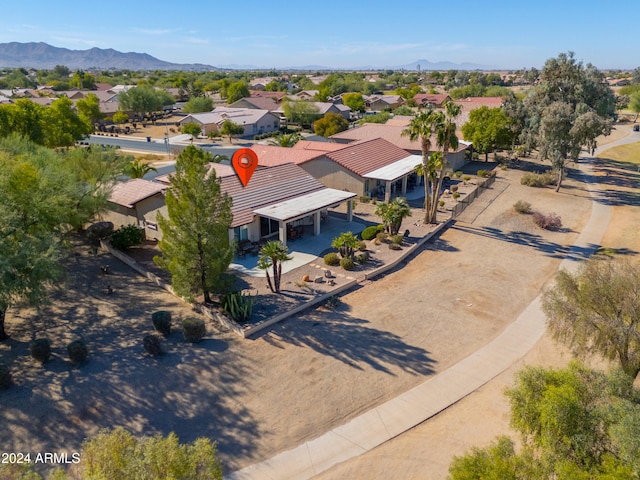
[[220, 163, 326, 227]]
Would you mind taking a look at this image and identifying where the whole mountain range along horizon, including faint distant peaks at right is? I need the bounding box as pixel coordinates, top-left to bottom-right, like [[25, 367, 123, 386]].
[[0, 42, 498, 71]]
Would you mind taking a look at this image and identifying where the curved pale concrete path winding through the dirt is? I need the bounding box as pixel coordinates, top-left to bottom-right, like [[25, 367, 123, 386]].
[[225, 148, 616, 480]]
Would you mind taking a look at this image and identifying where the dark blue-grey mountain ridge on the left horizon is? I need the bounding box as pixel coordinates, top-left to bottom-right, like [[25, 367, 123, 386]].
[[0, 42, 216, 71]]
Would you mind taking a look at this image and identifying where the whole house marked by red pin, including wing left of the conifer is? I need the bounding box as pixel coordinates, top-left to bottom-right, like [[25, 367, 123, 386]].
[[105, 163, 356, 248]]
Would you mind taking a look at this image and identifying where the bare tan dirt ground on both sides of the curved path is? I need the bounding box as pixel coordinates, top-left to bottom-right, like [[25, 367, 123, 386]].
[[0, 125, 636, 478]]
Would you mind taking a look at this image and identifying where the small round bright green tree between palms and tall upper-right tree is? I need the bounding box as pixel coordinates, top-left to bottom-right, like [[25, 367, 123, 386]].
[[462, 106, 512, 161]]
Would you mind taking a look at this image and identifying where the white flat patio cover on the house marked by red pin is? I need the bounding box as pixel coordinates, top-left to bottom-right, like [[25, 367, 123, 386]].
[[253, 188, 357, 221]]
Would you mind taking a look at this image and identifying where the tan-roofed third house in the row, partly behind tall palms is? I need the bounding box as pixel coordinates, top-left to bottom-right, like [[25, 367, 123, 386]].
[[329, 123, 471, 170]]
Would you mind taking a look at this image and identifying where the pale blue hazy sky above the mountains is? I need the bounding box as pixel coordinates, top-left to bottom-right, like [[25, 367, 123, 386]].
[[0, 0, 640, 69]]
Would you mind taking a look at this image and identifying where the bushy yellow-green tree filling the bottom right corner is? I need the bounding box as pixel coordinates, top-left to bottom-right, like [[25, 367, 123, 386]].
[[449, 363, 640, 480]]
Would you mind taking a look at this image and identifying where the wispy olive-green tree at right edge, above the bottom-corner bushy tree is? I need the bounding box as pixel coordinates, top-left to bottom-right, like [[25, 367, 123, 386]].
[[542, 260, 640, 378]]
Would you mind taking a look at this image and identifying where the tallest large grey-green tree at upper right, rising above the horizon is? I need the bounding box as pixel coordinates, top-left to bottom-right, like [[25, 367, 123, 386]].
[[523, 52, 615, 191]]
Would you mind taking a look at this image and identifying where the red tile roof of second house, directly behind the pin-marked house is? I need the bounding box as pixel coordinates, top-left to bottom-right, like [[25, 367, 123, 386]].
[[325, 138, 409, 176]]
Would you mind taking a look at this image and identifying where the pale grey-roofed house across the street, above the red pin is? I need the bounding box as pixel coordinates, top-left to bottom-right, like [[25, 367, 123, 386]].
[[179, 107, 280, 138]]
